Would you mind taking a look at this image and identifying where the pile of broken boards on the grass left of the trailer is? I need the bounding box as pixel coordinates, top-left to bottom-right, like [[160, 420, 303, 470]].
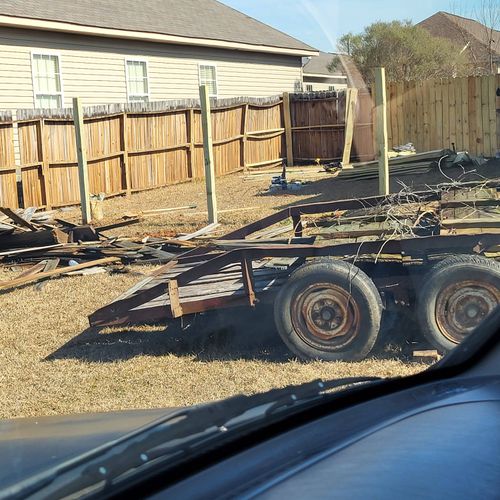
[[0, 207, 211, 290]]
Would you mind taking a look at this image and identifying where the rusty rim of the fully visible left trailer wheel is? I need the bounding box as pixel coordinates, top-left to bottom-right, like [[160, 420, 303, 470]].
[[291, 283, 360, 348]]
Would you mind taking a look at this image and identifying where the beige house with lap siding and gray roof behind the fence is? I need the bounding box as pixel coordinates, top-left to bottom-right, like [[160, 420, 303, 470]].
[[0, 0, 318, 110]]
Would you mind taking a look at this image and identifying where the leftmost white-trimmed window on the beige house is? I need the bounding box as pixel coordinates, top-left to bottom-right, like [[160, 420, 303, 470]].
[[31, 53, 63, 108]]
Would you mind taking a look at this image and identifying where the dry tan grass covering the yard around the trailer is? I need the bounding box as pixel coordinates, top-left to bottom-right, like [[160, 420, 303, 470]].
[[0, 175, 425, 418]]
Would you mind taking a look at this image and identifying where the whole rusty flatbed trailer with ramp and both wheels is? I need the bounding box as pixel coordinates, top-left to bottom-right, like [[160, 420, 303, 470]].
[[89, 181, 500, 359]]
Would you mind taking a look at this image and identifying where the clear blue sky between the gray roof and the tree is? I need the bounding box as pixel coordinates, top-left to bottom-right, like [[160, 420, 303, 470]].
[[221, 0, 479, 52]]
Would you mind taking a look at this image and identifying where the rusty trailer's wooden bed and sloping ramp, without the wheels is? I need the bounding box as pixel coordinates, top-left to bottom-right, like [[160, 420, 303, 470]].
[[89, 181, 500, 326]]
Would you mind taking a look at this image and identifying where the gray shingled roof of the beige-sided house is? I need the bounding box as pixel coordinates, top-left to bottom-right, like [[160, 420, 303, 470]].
[[0, 0, 316, 51]]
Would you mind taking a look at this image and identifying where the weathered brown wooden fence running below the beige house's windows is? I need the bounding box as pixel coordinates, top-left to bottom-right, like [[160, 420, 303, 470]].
[[0, 92, 373, 208]]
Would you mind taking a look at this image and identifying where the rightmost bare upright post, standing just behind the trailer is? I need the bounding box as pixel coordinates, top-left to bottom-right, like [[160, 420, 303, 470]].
[[375, 68, 389, 195]]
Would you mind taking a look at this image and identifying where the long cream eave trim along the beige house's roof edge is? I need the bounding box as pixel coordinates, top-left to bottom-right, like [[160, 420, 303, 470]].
[[0, 15, 319, 57]]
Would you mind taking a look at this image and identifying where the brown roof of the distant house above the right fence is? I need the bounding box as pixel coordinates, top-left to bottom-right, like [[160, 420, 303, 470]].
[[418, 11, 500, 62]]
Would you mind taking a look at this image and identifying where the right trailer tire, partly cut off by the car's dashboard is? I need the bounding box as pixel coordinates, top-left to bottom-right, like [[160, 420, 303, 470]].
[[417, 255, 500, 353]]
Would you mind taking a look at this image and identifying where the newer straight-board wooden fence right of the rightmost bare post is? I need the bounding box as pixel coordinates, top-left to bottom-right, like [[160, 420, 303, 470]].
[[386, 75, 500, 156]]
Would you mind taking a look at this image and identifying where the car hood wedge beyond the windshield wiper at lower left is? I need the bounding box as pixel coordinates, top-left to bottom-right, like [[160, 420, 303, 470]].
[[0, 409, 176, 488]]
